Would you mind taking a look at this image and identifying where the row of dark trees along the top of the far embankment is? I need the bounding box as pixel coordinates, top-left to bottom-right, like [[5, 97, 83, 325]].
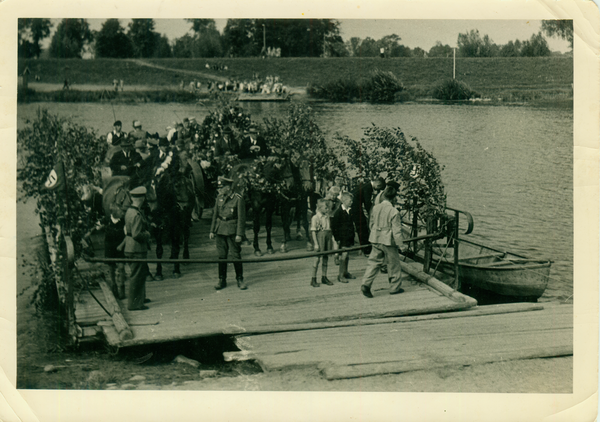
[[18, 18, 573, 58]]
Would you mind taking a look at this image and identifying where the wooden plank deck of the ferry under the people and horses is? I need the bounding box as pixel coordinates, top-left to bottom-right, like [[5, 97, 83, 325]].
[[76, 209, 476, 347]]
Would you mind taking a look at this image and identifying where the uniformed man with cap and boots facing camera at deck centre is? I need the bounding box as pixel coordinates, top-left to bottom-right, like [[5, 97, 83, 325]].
[[210, 177, 247, 290]]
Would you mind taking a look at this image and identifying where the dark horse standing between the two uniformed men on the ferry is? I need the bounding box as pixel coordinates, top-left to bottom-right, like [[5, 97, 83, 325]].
[[153, 169, 196, 280]]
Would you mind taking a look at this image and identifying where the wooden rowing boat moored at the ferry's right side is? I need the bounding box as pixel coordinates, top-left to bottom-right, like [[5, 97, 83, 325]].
[[431, 238, 552, 299]]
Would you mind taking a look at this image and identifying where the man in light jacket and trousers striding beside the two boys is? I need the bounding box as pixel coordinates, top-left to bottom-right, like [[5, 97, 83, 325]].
[[360, 186, 404, 298]]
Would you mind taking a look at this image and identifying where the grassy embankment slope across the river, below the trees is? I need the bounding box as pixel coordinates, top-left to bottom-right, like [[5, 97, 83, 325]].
[[19, 57, 573, 102]]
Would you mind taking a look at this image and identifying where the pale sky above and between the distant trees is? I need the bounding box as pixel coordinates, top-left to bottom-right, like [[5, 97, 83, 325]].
[[44, 19, 570, 53]]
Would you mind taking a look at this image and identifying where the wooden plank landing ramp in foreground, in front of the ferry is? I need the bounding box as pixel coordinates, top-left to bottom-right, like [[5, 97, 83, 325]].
[[226, 304, 573, 379]]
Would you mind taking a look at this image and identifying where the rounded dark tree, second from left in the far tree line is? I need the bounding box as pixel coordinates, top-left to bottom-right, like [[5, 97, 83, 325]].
[[50, 19, 94, 59]]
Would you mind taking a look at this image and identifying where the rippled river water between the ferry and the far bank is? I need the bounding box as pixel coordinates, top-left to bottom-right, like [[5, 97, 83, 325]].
[[18, 102, 573, 301]]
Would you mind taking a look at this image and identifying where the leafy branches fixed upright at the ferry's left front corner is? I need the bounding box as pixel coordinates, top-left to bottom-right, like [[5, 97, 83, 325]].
[[17, 109, 107, 312]]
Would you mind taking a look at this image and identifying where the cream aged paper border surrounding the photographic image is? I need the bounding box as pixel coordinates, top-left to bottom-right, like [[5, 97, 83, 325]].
[[0, 0, 600, 422]]
